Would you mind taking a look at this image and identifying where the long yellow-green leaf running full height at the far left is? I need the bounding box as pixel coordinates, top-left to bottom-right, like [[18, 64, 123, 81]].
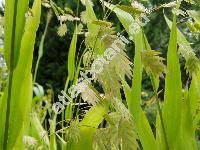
[[0, 0, 41, 150]]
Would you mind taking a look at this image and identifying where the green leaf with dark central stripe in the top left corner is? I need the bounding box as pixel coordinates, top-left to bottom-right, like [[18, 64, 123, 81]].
[[4, 0, 29, 67]]
